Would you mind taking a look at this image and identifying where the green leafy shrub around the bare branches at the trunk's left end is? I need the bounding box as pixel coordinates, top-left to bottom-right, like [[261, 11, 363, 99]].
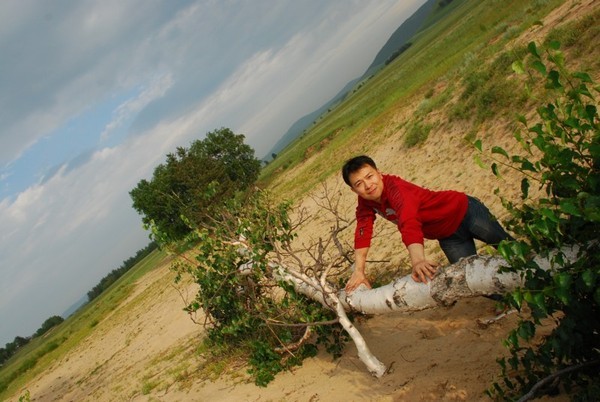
[[173, 192, 347, 386]]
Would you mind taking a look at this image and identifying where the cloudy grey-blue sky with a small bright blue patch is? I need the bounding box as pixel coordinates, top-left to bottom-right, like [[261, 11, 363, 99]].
[[0, 0, 425, 347]]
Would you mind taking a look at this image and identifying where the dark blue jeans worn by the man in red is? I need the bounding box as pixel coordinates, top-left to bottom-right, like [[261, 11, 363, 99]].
[[439, 196, 512, 264]]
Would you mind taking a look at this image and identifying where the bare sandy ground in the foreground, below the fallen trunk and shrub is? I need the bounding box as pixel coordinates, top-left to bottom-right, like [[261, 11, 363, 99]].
[[12, 260, 528, 401]]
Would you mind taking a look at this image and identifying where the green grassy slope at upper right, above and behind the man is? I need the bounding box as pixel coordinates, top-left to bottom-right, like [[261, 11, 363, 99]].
[[261, 0, 598, 199]]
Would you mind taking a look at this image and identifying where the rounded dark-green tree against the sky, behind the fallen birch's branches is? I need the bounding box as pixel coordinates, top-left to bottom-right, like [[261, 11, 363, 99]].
[[129, 128, 260, 240]]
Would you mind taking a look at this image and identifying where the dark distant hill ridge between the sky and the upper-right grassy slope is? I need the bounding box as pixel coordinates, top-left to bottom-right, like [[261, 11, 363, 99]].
[[263, 0, 438, 161]]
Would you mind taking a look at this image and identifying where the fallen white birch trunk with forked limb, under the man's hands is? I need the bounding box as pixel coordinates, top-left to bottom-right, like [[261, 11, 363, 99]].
[[270, 247, 579, 378]]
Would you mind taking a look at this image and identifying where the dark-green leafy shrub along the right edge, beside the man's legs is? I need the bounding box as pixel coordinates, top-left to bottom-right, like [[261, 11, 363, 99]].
[[476, 42, 600, 400]]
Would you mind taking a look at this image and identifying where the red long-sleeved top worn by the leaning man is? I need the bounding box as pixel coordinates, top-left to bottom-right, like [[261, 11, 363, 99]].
[[354, 174, 468, 249]]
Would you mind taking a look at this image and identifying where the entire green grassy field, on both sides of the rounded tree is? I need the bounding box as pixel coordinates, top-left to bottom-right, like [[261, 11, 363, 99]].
[[0, 0, 600, 400]]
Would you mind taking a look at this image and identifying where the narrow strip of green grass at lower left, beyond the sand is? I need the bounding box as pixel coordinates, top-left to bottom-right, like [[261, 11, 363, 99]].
[[0, 250, 166, 400]]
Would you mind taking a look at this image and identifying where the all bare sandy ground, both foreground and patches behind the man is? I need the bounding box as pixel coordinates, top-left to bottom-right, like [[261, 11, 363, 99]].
[[14, 0, 598, 402]]
